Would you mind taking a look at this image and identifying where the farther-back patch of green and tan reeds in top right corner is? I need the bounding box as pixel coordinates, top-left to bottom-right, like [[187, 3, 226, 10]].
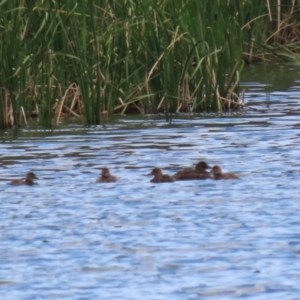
[[242, 0, 300, 63]]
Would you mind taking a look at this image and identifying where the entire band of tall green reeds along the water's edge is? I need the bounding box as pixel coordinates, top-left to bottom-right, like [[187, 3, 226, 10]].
[[0, 0, 300, 129]]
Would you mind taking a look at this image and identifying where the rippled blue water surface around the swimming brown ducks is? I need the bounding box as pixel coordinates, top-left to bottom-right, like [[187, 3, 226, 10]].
[[0, 66, 300, 300]]
